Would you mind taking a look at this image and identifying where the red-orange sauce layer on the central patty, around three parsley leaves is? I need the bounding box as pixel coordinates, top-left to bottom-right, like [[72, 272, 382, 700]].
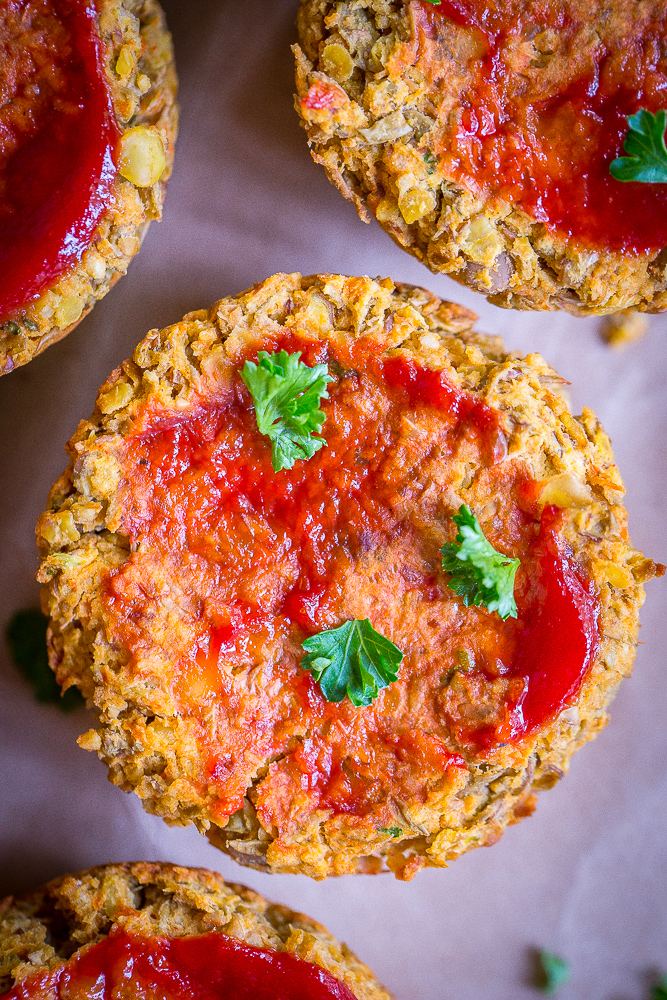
[[105, 334, 598, 829]]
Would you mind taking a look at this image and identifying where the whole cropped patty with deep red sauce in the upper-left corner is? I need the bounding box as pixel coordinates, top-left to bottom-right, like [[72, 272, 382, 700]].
[[0, 0, 178, 374]]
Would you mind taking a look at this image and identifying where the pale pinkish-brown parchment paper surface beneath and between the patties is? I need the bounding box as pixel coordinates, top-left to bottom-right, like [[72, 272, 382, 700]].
[[0, 0, 667, 1000]]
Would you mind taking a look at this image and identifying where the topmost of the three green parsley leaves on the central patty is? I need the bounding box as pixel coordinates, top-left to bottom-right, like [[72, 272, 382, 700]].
[[241, 351, 333, 472]]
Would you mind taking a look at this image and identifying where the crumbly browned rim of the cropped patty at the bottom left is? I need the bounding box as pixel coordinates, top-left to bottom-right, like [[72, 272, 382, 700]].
[[0, 862, 391, 1000]]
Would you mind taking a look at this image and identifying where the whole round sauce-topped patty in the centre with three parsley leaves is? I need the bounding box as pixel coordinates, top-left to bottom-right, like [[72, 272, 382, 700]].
[[37, 274, 663, 879]]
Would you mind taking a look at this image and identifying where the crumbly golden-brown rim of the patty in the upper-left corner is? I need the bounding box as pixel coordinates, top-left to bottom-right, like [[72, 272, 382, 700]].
[[0, 0, 178, 375]]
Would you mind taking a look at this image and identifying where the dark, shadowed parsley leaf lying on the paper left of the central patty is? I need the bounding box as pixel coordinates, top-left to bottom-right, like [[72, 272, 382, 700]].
[[7, 608, 83, 712]]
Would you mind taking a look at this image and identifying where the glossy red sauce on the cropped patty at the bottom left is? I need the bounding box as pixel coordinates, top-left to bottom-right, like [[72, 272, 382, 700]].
[[5, 930, 354, 1000]]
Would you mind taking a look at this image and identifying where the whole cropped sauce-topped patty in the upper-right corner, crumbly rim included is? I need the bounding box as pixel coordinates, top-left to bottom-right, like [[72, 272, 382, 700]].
[[295, 0, 667, 314]]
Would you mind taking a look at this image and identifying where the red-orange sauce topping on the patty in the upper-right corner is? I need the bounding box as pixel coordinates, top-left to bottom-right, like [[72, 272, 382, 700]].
[[414, 0, 667, 254]]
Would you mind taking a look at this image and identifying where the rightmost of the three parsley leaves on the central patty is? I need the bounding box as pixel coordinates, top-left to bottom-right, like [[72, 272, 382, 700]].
[[440, 504, 519, 618]]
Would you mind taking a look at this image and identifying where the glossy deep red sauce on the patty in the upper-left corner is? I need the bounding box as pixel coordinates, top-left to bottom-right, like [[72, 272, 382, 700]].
[[0, 0, 120, 321]]
